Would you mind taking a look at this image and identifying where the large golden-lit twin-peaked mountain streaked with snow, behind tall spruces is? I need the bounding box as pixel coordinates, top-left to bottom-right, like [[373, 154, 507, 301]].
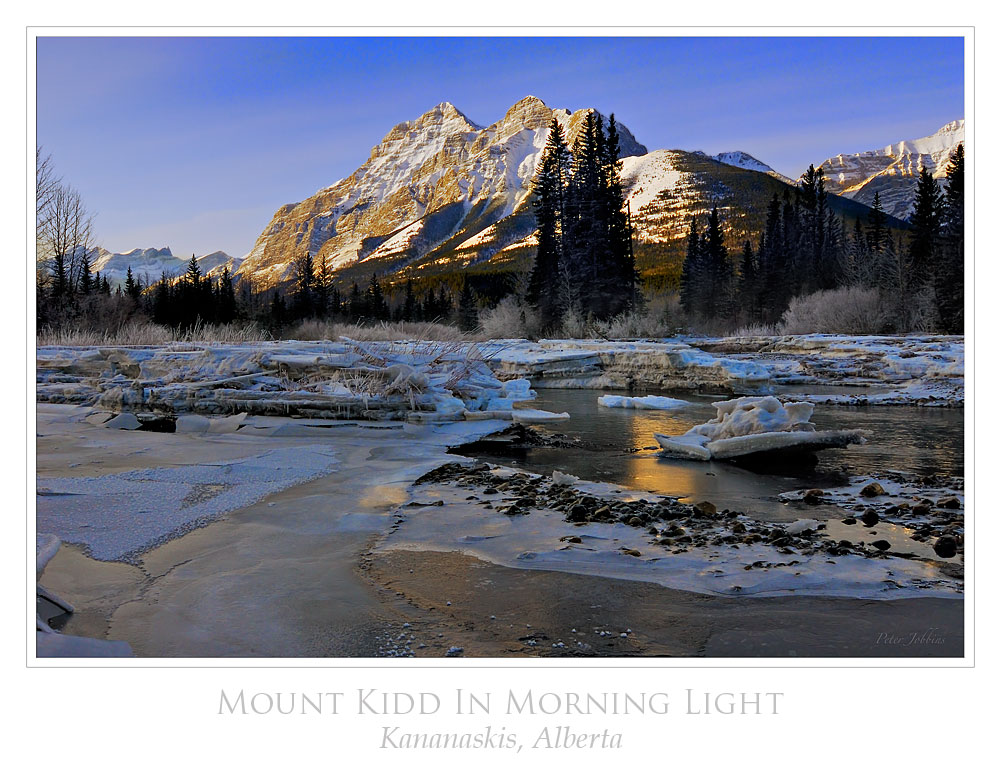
[[233, 96, 647, 287]]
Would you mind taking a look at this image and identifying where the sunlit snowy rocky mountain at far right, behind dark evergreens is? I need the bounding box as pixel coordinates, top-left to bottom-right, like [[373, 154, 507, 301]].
[[821, 120, 966, 218]]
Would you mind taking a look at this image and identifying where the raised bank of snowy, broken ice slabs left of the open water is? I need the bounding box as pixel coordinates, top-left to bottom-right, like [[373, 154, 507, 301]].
[[36, 338, 534, 423]]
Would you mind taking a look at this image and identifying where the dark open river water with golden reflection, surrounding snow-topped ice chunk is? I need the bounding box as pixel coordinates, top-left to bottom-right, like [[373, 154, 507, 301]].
[[463, 389, 963, 521]]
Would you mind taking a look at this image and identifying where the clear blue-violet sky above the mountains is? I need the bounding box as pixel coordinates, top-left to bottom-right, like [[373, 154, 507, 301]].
[[37, 37, 964, 257]]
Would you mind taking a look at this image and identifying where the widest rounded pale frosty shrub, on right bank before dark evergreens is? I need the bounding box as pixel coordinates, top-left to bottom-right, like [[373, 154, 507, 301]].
[[780, 286, 885, 335]]
